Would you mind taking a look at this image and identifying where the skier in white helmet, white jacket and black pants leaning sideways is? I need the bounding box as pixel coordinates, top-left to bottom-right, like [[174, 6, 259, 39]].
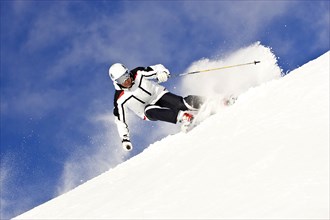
[[109, 63, 203, 151]]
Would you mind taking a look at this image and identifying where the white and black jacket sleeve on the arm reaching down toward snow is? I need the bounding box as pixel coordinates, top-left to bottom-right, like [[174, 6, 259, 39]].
[[113, 90, 129, 141]]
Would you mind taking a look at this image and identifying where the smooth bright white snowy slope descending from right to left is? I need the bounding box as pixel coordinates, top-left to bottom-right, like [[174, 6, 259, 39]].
[[17, 52, 330, 219]]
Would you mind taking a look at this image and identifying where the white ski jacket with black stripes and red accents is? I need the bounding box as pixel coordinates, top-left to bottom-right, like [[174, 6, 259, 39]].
[[113, 64, 168, 140]]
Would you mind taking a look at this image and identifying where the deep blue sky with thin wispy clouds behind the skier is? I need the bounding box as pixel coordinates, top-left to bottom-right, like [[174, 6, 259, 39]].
[[0, 1, 330, 218]]
